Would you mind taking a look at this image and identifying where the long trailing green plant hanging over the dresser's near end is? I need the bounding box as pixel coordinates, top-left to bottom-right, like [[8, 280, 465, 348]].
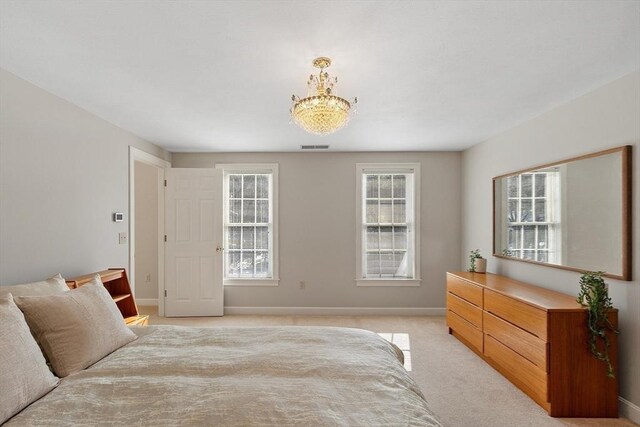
[[578, 271, 619, 378]]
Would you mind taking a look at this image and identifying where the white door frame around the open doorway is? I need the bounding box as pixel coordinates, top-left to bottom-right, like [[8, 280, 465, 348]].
[[129, 145, 171, 316]]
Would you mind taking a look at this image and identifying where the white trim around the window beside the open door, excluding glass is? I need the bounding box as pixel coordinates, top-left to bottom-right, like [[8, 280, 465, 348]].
[[214, 163, 280, 286]]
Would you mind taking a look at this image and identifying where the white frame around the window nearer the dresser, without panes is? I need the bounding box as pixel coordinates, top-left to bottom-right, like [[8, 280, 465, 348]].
[[355, 163, 422, 287]]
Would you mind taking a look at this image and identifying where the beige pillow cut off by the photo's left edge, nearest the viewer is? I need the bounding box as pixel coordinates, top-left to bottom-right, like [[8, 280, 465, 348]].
[[0, 294, 58, 424]]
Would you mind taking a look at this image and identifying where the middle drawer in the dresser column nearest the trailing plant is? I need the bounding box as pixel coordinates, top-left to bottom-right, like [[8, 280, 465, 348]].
[[482, 311, 548, 372]]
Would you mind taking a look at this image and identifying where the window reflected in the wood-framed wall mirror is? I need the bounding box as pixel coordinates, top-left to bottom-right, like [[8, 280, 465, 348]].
[[505, 169, 560, 263]]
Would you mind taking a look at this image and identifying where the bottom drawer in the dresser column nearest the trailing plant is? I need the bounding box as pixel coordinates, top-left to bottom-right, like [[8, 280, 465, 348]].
[[484, 335, 548, 402]]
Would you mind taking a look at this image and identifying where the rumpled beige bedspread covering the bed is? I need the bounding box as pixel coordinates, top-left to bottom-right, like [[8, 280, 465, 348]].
[[7, 326, 440, 427]]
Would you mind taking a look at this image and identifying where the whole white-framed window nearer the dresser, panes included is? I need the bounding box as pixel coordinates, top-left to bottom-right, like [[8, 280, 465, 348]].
[[356, 163, 420, 286]]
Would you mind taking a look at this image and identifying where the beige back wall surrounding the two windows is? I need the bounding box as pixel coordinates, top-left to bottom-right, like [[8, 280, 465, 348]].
[[172, 152, 461, 307]]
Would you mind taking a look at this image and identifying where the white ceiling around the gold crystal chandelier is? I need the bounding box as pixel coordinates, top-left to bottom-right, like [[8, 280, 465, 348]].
[[0, 0, 640, 151]]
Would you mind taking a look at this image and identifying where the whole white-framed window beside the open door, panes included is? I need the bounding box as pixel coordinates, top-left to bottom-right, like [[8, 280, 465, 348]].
[[217, 164, 278, 286]]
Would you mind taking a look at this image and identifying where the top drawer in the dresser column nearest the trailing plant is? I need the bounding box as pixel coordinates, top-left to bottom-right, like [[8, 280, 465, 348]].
[[484, 289, 547, 341]]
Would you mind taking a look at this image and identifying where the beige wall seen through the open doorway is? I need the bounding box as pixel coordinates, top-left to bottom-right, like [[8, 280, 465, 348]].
[[134, 162, 160, 304]]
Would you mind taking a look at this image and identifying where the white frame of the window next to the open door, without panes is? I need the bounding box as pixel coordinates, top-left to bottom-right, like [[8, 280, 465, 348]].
[[215, 163, 280, 286]]
